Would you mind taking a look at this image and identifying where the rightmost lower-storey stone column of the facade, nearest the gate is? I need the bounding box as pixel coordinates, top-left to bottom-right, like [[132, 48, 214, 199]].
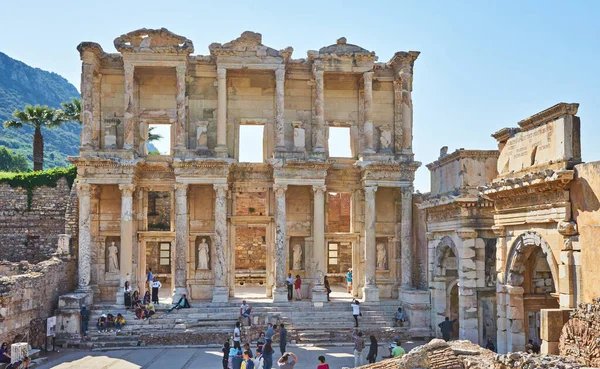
[[400, 187, 413, 289]]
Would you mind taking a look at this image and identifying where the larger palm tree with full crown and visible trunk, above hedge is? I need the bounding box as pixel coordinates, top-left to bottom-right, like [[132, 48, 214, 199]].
[[4, 105, 64, 171]]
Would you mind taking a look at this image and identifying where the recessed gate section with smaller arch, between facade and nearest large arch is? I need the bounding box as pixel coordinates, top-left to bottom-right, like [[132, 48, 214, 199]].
[[419, 147, 498, 345]]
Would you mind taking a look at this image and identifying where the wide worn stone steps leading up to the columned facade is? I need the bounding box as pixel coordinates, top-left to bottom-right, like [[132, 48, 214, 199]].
[[79, 300, 408, 348]]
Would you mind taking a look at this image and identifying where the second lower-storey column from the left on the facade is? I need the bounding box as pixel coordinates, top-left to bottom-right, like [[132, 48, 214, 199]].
[[116, 184, 134, 305]]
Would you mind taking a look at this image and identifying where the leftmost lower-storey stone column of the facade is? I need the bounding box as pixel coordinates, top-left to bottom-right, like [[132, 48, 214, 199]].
[[77, 183, 92, 292]]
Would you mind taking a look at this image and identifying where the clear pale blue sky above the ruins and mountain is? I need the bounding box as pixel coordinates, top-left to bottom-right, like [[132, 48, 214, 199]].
[[0, 0, 600, 192]]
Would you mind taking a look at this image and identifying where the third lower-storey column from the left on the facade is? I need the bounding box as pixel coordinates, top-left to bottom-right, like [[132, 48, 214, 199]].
[[173, 183, 189, 301]]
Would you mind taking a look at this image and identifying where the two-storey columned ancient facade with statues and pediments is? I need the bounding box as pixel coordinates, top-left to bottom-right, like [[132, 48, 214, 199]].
[[72, 29, 428, 329]]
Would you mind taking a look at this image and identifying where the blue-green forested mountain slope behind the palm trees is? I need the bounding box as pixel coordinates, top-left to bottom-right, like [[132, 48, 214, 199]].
[[0, 52, 81, 169]]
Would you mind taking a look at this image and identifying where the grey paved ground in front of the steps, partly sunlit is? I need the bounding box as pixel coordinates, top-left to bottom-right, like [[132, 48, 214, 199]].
[[36, 342, 423, 369]]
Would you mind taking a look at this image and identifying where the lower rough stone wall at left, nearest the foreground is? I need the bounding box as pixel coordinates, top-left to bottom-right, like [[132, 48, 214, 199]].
[[0, 258, 77, 347]]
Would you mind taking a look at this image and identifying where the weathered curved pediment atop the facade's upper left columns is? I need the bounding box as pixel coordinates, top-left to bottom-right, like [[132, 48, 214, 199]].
[[114, 28, 194, 54]]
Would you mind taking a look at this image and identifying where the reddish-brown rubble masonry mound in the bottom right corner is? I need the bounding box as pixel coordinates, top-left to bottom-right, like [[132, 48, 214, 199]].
[[558, 298, 600, 367]]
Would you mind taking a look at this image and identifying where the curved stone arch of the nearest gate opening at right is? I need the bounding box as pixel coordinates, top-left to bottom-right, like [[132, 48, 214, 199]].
[[504, 231, 558, 291]]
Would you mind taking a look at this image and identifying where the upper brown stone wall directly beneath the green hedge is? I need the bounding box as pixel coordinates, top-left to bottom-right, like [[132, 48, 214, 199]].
[[0, 178, 76, 263]]
